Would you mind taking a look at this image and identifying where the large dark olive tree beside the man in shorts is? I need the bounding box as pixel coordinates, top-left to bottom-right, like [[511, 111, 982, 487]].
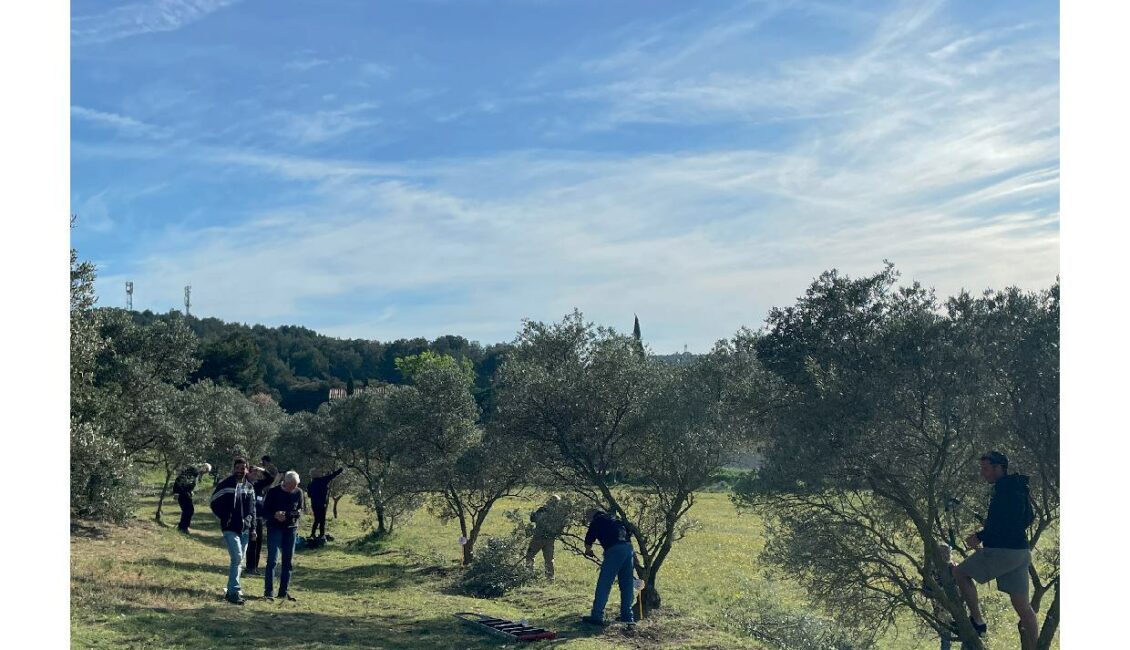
[[735, 265, 1058, 648]]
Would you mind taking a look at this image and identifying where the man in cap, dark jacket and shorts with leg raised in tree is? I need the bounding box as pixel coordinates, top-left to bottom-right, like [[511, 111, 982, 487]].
[[954, 451, 1038, 650]]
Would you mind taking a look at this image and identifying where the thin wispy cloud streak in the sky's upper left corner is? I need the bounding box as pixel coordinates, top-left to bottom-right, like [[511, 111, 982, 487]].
[[71, 0, 242, 45]]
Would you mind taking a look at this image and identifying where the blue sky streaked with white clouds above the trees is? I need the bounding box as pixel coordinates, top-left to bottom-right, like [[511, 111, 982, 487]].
[[71, 0, 1060, 353]]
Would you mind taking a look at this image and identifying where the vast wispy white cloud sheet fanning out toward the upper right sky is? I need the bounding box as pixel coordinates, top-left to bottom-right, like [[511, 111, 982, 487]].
[[72, 0, 1059, 352]]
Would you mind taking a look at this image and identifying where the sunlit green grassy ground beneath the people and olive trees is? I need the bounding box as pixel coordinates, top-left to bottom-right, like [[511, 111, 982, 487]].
[[71, 486, 1048, 650]]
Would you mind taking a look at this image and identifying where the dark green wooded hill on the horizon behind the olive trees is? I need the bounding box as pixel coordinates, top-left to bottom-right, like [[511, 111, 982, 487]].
[[131, 310, 695, 415]]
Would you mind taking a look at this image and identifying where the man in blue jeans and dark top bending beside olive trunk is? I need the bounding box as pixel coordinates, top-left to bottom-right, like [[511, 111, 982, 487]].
[[581, 510, 635, 625]]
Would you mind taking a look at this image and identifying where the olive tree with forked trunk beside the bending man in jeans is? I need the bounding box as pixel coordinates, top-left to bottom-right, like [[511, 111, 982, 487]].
[[493, 311, 762, 608]]
